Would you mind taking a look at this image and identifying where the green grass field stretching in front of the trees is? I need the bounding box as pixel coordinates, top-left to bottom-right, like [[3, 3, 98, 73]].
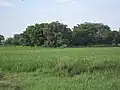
[[0, 47, 120, 90]]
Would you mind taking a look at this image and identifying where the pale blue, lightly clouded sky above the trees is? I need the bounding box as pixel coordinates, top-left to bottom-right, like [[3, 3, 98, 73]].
[[0, 0, 120, 37]]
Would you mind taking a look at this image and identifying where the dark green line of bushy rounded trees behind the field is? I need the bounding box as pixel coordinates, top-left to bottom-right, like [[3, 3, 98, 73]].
[[0, 21, 120, 47]]
